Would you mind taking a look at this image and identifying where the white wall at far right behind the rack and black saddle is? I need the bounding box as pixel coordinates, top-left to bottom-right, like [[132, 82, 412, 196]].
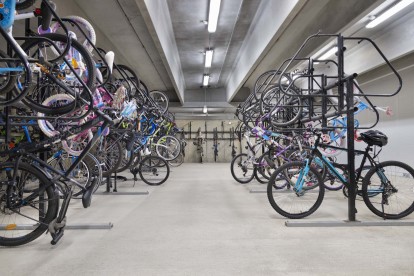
[[332, 54, 414, 167]]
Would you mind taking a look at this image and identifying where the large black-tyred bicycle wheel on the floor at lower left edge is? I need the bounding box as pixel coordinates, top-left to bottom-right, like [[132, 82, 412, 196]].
[[0, 162, 59, 246]]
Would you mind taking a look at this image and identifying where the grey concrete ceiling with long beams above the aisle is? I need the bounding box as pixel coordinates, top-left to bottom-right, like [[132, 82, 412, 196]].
[[50, 0, 414, 118]]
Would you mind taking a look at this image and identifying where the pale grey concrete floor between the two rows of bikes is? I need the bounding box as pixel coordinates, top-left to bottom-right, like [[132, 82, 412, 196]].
[[0, 164, 414, 275]]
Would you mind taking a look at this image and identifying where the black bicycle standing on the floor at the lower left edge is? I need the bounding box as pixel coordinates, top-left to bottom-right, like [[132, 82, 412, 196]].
[[0, 102, 114, 246]]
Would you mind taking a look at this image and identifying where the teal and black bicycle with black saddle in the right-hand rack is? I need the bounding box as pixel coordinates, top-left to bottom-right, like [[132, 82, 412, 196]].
[[267, 130, 414, 219]]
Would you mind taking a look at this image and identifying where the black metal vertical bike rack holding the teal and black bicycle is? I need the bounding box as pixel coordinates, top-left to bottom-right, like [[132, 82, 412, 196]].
[[254, 33, 414, 227]]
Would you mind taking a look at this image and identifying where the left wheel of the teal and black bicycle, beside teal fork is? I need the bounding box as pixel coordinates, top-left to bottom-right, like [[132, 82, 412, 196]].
[[267, 162, 325, 219]]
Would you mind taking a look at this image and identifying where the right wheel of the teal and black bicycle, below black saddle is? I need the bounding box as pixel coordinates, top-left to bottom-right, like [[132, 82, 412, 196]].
[[362, 161, 414, 219]]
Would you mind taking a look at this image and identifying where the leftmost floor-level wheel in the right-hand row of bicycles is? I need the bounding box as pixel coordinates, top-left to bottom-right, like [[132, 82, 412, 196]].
[[230, 153, 254, 184]]
